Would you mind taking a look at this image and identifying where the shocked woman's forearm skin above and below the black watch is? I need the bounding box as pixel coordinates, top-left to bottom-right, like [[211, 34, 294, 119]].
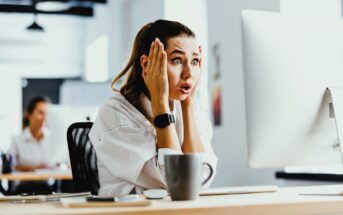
[[152, 101, 181, 152]]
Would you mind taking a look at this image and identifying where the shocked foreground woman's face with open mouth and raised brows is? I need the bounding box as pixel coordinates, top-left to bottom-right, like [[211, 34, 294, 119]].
[[165, 36, 201, 100]]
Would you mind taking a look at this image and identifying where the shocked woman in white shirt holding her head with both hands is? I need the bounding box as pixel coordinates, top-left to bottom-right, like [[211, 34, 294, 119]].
[[89, 20, 217, 196]]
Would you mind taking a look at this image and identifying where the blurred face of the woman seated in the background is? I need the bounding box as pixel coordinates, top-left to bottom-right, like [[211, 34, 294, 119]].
[[29, 102, 48, 129]]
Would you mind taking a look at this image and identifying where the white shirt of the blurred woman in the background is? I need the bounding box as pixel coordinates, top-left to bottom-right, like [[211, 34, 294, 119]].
[[9, 128, 50, 166]]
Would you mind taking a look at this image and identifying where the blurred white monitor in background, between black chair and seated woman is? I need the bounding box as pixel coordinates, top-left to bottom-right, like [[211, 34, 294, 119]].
[[47, 105, 98, 164]]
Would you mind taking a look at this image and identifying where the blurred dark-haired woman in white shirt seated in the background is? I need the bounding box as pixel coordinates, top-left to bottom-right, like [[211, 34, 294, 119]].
[[9, 97, 51, 193]]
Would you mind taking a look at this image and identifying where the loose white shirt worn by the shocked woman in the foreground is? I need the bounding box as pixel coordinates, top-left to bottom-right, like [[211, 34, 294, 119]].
[[89, 93, 217, 196]]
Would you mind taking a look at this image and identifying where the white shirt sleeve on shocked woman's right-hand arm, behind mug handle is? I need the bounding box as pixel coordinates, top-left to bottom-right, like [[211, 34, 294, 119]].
[[196, 101, 218, 188]]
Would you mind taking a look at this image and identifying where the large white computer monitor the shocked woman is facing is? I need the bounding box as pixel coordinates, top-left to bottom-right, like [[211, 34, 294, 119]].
[[241, 11, 343, 168]]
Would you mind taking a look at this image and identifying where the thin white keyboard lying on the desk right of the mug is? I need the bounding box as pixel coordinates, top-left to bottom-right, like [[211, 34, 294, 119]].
[[200, 185, 278, 196]]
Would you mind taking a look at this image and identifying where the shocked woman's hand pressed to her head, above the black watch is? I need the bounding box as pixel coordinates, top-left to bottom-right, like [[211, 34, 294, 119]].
[[142, 38, 169, 115]]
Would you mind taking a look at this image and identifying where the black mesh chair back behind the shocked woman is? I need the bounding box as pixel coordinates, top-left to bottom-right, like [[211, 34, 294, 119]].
[[67, 122, 100, 195]]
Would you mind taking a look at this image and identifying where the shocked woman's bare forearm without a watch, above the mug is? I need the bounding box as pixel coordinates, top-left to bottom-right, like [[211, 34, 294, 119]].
[[182, 103, 205, 153]]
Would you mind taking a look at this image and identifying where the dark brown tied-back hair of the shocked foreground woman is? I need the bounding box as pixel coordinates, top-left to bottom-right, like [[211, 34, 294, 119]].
[[112, 19, 195, 113]]
